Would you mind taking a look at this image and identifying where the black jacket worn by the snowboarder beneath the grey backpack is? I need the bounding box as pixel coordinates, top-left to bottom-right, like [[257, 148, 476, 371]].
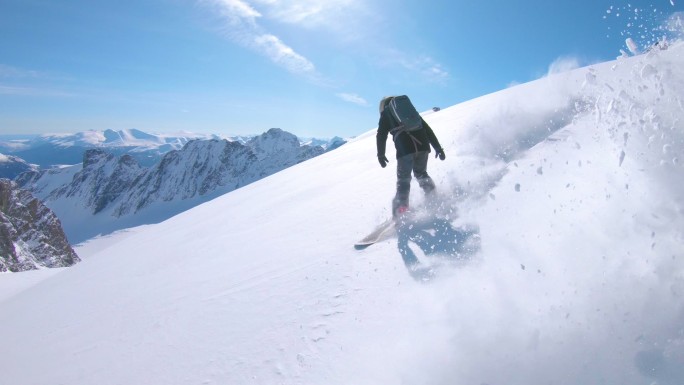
[[375, 108, 442, 159]]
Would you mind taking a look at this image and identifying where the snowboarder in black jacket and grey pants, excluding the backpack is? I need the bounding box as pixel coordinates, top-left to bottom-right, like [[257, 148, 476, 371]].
[[376, 96, 445, 218]]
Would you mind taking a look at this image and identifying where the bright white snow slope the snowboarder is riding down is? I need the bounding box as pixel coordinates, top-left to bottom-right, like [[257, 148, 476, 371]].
[[0, 45, 684, 385]]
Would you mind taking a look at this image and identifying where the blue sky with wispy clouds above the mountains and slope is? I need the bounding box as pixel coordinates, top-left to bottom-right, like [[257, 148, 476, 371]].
[[0, 0, 684, 137]]
